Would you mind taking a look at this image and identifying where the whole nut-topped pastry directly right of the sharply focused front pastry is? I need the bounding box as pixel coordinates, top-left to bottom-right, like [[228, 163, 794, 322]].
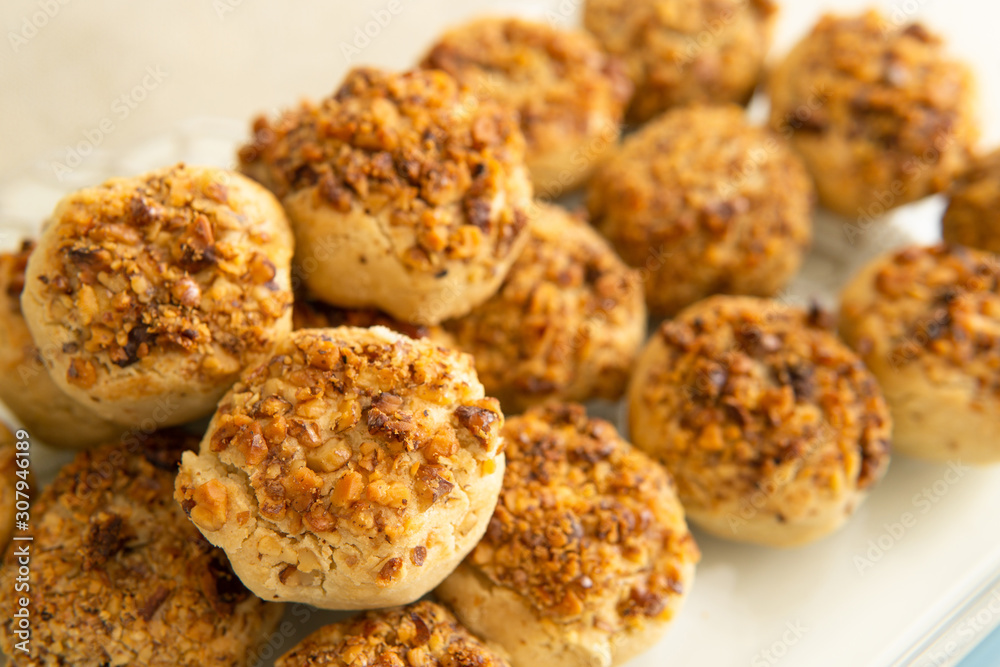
[[435, 403, 700, 667]]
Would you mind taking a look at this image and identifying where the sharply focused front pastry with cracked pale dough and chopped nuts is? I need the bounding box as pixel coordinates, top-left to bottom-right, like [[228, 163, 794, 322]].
[[176, 327, 504, 609]]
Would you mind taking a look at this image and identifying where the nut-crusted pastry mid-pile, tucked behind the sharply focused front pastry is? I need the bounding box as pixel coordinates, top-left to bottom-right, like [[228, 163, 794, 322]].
[[445, 204, 646, 412]]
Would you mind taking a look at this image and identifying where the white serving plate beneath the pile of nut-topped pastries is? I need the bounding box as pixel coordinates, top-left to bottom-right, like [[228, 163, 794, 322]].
[[0, 0, 1000, 667]]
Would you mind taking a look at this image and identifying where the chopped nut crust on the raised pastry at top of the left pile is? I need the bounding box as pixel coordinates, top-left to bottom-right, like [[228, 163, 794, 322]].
[[240, 68, 530, 276]]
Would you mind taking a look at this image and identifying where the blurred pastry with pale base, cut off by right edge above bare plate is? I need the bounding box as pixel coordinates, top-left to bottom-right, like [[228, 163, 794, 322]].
[[840, 245, 1000, 465]]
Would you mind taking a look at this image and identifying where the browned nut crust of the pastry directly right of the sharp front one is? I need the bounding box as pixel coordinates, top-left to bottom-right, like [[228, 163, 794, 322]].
[[466, 403, 700, 635]]
